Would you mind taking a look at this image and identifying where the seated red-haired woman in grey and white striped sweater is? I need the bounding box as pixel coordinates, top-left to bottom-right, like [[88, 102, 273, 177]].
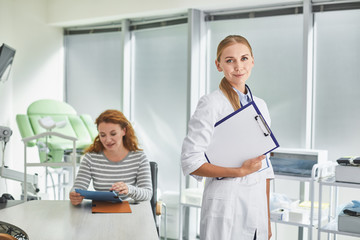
[[69, 110, 152, 205]]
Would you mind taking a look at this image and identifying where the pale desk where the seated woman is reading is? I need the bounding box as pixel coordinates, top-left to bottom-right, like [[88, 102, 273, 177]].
[[0, 200, 159, 240]]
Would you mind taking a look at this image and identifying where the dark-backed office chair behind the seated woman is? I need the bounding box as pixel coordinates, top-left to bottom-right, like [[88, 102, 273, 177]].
[[150, 162, 167, 240]]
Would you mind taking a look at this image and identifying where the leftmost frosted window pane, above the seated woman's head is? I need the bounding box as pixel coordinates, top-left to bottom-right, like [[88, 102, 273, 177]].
[[65, 32, 123, 119]]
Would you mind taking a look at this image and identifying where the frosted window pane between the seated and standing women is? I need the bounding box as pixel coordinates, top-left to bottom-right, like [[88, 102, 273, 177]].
[[132, 24, 187, 191]]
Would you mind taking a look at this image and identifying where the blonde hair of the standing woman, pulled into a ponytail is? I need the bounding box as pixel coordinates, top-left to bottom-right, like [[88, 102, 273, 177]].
[[216, 35, 253, 111]]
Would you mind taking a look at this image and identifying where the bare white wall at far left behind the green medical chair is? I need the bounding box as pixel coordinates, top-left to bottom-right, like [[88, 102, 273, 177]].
[[0, 0, 64, 198]]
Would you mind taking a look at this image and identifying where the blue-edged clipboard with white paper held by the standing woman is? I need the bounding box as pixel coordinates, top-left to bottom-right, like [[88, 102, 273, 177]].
[[205, 101, 279, 171]]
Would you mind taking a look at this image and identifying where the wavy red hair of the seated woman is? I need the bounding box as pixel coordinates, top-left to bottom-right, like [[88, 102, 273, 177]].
[[84, 110, 142, 153]]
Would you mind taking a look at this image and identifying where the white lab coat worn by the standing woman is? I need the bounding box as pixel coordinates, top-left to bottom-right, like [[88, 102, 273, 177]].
[[181, 90, 274, 240]]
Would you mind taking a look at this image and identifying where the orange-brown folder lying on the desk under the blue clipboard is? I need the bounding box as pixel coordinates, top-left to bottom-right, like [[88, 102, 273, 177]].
[[91, 201, 131, 213]]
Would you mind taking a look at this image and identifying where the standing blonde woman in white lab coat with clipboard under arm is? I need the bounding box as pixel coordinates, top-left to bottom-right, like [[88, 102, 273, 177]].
[[181, 35, 274, 240]]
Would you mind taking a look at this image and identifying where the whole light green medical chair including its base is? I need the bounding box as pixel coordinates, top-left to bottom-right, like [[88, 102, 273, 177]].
[[16, 99, 97, 199]]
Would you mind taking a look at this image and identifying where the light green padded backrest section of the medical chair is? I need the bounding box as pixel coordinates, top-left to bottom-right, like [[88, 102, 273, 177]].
[[16, 99, 97, 162]]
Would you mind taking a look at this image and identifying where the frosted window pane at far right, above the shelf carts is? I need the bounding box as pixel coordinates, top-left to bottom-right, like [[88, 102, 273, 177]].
[[314, 10, 360, 161]]
